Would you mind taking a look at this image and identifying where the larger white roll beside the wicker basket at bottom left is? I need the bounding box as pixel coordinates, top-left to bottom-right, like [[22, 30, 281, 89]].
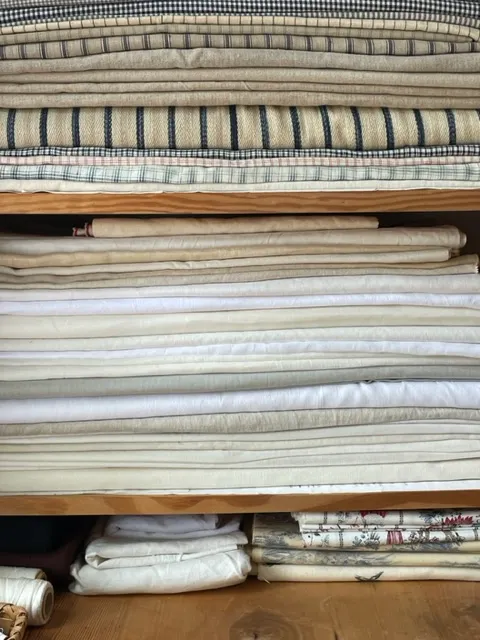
[[0, 578, 54, 627]]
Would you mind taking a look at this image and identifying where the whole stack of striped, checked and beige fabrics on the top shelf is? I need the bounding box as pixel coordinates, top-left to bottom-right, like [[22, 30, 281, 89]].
[[0, 0, 480, 193]]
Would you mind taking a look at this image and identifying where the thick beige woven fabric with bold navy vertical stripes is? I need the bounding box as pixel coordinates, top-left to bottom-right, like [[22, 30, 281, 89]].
[[0, 106, 480, 151]]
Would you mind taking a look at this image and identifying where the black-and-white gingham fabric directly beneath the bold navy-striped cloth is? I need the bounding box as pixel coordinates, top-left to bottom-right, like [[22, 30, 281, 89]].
[[0, 144, 480, 159]]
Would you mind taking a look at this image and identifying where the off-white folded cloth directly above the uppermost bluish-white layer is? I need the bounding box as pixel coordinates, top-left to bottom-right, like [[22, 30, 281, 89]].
[[0, 274, 480, 302]]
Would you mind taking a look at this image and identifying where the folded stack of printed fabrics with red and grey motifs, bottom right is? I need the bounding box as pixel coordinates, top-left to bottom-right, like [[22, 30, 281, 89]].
[[251, 510, 480, 582]]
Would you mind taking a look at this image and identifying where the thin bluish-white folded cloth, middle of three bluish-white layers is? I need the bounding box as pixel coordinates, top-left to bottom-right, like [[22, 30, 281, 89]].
[[0, 340, 480, 366]]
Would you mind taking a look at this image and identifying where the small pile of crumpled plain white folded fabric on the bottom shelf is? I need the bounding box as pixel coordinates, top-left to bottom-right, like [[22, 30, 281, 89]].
[[70, 515, 250, 595]]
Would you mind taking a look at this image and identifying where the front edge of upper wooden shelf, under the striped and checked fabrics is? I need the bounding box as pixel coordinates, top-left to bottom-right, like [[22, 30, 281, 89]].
[[0, 189, 480, 215]]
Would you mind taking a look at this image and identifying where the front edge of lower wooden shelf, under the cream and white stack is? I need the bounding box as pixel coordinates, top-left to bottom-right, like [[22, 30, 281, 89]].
[[0, 489, 480, 515]]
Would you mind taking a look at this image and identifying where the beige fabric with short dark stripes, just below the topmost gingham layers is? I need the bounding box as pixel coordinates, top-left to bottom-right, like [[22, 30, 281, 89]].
[[0, 33, 480, 60]]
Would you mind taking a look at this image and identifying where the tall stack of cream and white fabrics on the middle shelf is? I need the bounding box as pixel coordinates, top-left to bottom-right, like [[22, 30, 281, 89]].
[[0, 216, 480, 494]]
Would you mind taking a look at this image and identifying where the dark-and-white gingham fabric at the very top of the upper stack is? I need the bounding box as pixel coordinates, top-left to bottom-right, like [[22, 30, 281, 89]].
[[0, 0, 480, 25]]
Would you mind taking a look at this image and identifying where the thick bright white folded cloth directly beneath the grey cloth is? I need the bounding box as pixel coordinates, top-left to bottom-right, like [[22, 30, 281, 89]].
[[0, 380, 480, 424]]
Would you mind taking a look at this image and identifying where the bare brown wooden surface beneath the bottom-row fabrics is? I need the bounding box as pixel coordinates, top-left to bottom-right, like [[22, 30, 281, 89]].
[[28, 578, 480, 640]]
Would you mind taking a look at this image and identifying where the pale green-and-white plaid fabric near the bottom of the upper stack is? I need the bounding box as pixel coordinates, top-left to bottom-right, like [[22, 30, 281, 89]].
[[0, 163, 480, 185]]
